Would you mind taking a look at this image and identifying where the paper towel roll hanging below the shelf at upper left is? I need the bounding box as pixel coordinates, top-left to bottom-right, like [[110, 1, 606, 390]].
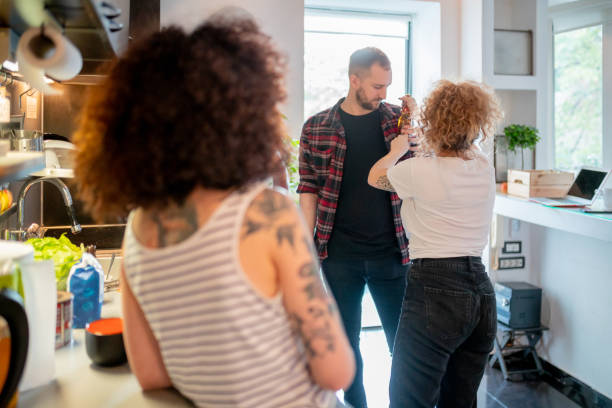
[[17, 27, 83, 94]]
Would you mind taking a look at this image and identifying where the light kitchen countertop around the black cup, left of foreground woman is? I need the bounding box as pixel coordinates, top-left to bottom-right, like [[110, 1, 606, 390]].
[[18, 292, 193, 408]]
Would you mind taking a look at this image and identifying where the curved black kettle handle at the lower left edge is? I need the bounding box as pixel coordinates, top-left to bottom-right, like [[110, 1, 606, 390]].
[[0, 288, 29, 407]]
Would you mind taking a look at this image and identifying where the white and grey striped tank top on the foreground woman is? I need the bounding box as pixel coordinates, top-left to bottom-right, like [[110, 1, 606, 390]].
[[124, 184, 338, 408]]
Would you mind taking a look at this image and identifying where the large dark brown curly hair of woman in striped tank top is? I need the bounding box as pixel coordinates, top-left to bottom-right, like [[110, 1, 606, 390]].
[[73, 14, 289, 220]]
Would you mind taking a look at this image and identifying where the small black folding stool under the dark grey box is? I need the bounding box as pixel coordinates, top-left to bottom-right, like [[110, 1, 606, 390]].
[[489, 322, 548, 380]]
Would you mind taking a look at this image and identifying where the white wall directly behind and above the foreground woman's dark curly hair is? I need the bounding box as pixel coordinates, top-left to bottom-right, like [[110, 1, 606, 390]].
[[160, 0, 304, 138]]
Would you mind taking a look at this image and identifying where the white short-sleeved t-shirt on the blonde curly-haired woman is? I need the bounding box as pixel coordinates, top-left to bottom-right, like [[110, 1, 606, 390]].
[[387, 151, 495, 259]]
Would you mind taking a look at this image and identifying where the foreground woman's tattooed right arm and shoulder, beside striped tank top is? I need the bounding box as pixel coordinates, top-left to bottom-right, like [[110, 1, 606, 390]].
[[240, 190, 355, 390]]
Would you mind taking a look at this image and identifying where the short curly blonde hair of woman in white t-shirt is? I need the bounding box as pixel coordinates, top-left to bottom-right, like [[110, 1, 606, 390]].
[[419, 80, 502, 155]]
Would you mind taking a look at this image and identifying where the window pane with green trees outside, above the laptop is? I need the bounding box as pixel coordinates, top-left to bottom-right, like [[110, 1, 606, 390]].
[[554, 25, 604, 169]]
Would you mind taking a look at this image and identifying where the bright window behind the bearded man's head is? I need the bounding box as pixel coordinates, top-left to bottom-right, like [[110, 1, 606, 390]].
[[304, 8, 410, 118]]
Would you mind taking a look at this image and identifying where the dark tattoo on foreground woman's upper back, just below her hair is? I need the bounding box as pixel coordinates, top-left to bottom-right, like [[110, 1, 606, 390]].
[[152, 203, 198, 248]]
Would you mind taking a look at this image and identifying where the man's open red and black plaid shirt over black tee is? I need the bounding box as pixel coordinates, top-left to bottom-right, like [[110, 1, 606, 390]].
[[297, 98, 411, 265]]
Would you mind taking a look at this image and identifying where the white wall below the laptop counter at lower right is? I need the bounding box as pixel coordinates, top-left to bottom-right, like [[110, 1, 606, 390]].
[[529, 225, 612, 398]]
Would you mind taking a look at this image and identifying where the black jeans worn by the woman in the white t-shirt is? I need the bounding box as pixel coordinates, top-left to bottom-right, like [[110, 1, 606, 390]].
[[389, 257, 497, 408]]
